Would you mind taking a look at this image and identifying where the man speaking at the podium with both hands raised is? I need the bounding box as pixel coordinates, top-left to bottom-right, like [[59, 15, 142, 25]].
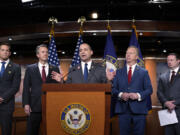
[[52, 43, 114, 83]]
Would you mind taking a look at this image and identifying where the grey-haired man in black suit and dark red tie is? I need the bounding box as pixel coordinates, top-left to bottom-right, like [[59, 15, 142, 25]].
[[23, 44, 59, 135]]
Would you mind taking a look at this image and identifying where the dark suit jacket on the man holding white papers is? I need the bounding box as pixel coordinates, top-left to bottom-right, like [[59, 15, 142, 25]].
[[157, 68, 180, 116]]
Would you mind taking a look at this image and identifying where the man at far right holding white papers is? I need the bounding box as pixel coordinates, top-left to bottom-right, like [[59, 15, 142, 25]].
[[157, 53, 180, 135]]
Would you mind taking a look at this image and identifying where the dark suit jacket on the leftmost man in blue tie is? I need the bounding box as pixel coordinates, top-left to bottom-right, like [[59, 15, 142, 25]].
[[0, 61, 21, 111]]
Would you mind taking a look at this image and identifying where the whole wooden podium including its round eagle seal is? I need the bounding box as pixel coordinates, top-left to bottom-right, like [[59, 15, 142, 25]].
[[42, 84, 111, 135]]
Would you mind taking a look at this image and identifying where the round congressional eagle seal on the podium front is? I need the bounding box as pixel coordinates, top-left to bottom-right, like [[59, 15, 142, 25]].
[[60, 103, 91, 135]]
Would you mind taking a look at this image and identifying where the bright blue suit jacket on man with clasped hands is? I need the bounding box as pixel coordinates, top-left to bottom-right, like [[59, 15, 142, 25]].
[[112, 66, 152, 114]]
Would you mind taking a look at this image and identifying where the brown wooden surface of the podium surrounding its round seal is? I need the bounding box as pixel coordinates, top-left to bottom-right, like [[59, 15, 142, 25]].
[[42, 84, 111, 135]]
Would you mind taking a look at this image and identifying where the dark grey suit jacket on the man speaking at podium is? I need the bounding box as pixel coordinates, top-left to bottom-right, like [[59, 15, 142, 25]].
[[66, 62, 107, 83]]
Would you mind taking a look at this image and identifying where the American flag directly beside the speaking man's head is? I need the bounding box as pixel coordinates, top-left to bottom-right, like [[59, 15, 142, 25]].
[[71, 34, 83, 67]]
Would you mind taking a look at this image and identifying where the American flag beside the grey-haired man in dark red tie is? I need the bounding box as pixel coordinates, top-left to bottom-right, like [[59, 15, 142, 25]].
[[48, 36, 60, 66]]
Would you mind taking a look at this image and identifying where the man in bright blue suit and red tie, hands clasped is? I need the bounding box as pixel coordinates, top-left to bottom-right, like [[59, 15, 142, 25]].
[[112, 46, 152, 135]]
